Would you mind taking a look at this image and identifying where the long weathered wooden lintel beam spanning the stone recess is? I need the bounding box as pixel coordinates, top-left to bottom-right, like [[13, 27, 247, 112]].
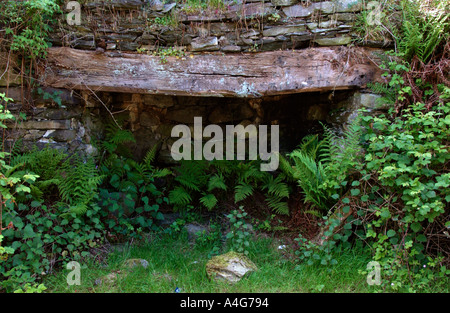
[[41, 47, 382, 98]]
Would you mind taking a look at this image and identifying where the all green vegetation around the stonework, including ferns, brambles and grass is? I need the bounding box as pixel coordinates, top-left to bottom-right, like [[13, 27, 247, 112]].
[[0, 0, 450, 292]]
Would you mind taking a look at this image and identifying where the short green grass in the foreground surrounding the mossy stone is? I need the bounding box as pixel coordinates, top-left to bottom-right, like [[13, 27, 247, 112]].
[[44, 229, 375, 293]]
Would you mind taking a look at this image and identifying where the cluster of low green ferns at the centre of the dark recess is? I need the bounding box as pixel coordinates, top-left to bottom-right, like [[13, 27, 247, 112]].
[[169, 160, 289, 214]]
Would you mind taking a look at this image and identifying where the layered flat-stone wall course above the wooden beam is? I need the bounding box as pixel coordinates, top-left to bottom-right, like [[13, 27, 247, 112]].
[[52, 0, 391, 53]]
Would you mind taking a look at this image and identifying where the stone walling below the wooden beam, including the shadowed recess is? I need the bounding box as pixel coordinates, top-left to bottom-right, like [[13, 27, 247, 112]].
[[0, 88, 387, 164]]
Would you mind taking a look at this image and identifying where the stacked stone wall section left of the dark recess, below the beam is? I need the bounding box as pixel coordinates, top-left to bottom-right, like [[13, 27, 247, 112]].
[[0, 87, 103, 155]]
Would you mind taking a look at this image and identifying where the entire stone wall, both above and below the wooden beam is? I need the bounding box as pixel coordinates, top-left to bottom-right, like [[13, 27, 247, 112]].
[[0, 0, 394, 163]]
